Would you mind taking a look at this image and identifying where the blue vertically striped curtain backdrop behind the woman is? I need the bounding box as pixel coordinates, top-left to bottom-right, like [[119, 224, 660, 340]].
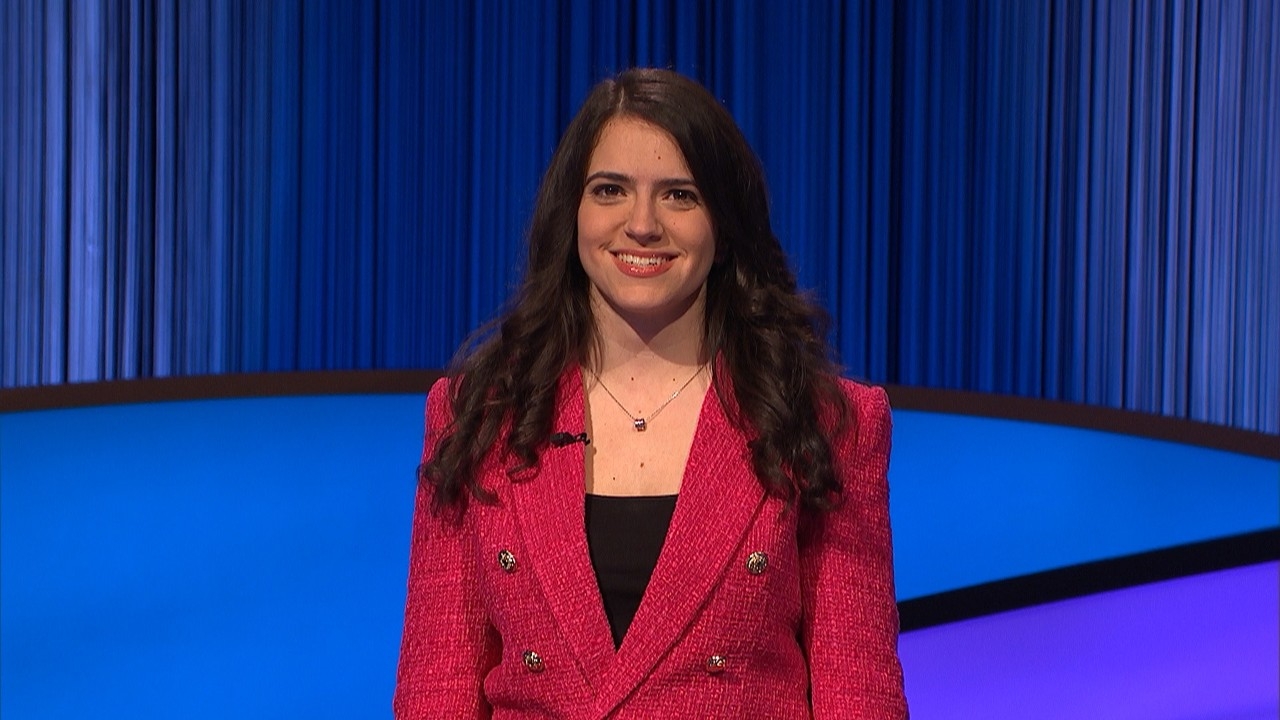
[[0, 0, 1280, 433]]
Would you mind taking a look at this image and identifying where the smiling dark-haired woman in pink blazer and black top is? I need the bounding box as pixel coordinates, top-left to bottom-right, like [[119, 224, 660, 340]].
[[394, 69, 906, 719]]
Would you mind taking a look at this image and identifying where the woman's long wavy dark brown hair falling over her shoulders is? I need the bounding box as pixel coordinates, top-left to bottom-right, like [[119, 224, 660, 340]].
[[420, 69, 849, 511]]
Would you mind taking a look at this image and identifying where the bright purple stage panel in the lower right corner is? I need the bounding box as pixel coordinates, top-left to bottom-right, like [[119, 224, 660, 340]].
[[900, 562, 1280, 720]]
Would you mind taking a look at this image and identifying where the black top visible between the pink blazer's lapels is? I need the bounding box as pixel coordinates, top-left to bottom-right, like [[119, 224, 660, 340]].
[[586, 495, 677, 648]]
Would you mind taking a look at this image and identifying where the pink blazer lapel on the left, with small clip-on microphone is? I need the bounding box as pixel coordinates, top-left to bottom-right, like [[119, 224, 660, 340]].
[[512, 368, 613, 688]]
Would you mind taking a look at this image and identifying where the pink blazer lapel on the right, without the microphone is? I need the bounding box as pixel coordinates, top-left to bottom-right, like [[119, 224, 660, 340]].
[[593, 381, 764, 717]]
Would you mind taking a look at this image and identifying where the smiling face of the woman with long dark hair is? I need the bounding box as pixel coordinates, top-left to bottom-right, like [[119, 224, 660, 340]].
[[577, 118, 716, 328]]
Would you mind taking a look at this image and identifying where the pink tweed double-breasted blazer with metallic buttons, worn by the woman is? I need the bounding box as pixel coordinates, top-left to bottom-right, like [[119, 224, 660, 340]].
[[393, 372, 906, 720]]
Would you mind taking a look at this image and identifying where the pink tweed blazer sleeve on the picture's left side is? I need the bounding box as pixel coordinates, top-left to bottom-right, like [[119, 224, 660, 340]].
[[392, 379, 499, 720]]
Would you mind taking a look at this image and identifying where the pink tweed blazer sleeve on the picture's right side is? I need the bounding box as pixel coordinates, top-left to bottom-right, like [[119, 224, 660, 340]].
[[800, 383, 908, 720]]
